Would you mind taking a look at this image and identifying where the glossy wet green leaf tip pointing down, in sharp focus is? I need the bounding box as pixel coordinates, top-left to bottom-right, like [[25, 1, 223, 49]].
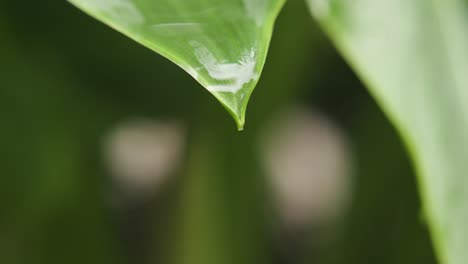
[[69, 0, 285, 130]]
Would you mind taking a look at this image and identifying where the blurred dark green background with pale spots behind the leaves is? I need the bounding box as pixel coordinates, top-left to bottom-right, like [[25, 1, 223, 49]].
[[0, 0, 435, 264]]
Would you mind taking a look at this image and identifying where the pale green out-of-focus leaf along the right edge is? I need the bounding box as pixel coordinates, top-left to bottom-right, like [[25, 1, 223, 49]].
[[308, 0, 468, 264]]
